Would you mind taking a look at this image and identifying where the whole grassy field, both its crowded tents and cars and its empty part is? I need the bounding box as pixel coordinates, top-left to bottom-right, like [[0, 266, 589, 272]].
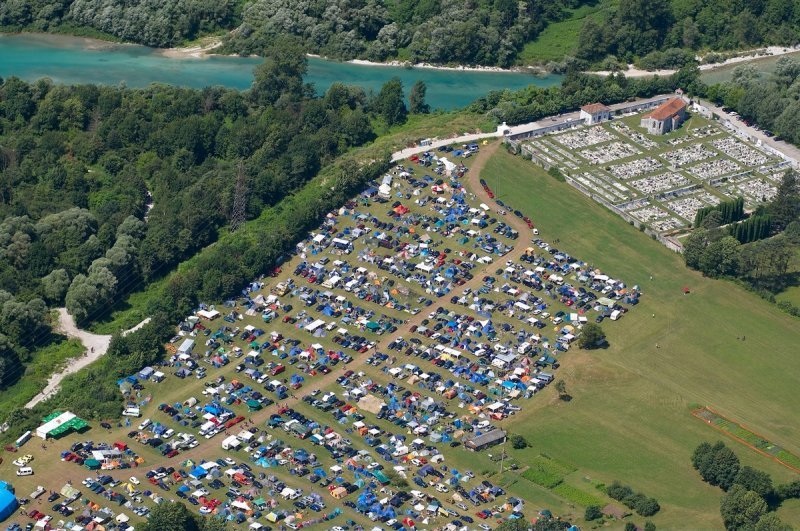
[[0, 129, 800, 529]]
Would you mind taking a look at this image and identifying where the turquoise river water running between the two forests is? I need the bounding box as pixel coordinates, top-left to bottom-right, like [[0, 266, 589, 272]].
[[0, 34, 561, 109]]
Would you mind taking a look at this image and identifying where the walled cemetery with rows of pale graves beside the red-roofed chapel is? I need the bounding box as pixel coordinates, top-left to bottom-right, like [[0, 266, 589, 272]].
[[521, 105, 789, 236]]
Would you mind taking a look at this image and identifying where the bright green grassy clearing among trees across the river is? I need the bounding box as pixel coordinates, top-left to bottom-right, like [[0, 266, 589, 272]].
[[517, 0, 616, 65]]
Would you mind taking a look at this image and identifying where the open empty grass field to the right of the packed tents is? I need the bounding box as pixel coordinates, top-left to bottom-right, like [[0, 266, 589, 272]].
[[484, 148, 800, 528]]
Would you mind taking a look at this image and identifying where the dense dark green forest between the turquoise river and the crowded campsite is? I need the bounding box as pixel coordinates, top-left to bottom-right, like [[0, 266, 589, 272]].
[[0, 38, 418, 390]]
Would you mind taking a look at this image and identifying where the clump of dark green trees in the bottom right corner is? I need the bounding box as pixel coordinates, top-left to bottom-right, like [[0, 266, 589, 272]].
[[692, 441, 800, 531]]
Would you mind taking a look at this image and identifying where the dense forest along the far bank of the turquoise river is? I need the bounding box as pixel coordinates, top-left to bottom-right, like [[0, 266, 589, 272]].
[[6, 0, 800, 69]]
